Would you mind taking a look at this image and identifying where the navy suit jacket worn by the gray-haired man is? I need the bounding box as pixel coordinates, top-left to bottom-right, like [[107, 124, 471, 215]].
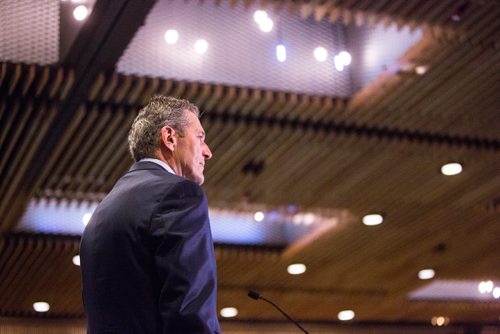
[[80, 162, 221, 334]]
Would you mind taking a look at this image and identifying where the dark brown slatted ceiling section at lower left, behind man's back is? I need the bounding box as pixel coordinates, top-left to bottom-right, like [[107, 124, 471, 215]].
[[0, 235, 82, 317]]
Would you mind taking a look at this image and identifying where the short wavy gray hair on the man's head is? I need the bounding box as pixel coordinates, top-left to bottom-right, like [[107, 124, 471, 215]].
[[128, 95, 200, 161]]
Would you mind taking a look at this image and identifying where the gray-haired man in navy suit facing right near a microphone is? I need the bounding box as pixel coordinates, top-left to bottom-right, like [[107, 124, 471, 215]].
[[80, 96, 221, 334]]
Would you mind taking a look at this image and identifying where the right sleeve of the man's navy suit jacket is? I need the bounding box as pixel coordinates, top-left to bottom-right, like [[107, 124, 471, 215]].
[[147, 180, 220, 333]]
